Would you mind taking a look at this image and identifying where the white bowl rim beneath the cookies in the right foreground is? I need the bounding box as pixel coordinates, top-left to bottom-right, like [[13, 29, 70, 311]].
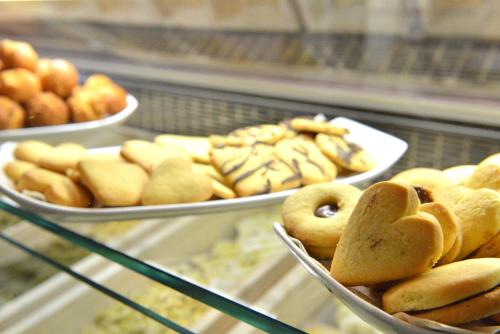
[[274, 223, 497, 334]]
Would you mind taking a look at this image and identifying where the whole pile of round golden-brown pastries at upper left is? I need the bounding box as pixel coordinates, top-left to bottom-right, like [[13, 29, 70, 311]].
[[0, 39, 127, 130]]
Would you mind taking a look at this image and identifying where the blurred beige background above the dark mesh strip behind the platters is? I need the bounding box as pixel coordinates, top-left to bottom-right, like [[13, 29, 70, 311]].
[[0, 0, 500, 126]]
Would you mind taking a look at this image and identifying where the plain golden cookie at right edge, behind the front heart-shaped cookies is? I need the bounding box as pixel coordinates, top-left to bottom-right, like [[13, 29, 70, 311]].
[[436, 186, 500, 260]]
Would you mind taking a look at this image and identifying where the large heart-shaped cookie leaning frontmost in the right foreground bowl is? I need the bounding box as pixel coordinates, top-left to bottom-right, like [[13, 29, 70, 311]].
[[331, 182, 443, 286]]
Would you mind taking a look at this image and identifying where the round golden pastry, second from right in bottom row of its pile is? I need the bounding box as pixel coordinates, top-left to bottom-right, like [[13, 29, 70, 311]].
[[67, 89, 108, 123]]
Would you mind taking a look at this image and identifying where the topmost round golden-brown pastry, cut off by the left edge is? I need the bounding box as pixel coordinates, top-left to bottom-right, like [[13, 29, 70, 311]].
[[0, 39, 38, 72]]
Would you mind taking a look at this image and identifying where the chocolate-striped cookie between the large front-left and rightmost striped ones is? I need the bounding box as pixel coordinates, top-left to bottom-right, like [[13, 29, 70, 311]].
[[276, 138, 337, 185]]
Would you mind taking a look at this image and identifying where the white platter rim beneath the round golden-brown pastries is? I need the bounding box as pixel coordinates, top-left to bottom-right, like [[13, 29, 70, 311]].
[[0, 94, 138, 142]]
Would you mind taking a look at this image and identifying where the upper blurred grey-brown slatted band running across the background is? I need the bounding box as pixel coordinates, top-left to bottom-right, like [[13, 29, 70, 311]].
[[5, 20, 500, 86]]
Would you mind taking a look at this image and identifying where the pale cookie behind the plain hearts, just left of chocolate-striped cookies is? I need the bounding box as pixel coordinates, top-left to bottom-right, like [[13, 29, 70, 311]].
[[155, 134, 212, 164]]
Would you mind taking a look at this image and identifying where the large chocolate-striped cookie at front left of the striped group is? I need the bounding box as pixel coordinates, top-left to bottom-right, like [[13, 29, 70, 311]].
[[212, 144, 300, 196]]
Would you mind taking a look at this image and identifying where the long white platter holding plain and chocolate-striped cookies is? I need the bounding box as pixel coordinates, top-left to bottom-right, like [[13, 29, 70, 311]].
[[0, 117, 408, 222]]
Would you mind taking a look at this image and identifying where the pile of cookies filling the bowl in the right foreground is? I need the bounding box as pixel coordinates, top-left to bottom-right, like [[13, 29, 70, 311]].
[[282, 154, 500, 325]]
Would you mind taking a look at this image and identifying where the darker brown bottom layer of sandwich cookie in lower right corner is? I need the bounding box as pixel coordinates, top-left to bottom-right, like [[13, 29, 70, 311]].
[[412, 287, 500, 325]]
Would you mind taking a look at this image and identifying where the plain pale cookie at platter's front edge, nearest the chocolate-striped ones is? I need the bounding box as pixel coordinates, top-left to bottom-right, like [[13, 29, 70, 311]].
[[141, 158, 213, 205]]
